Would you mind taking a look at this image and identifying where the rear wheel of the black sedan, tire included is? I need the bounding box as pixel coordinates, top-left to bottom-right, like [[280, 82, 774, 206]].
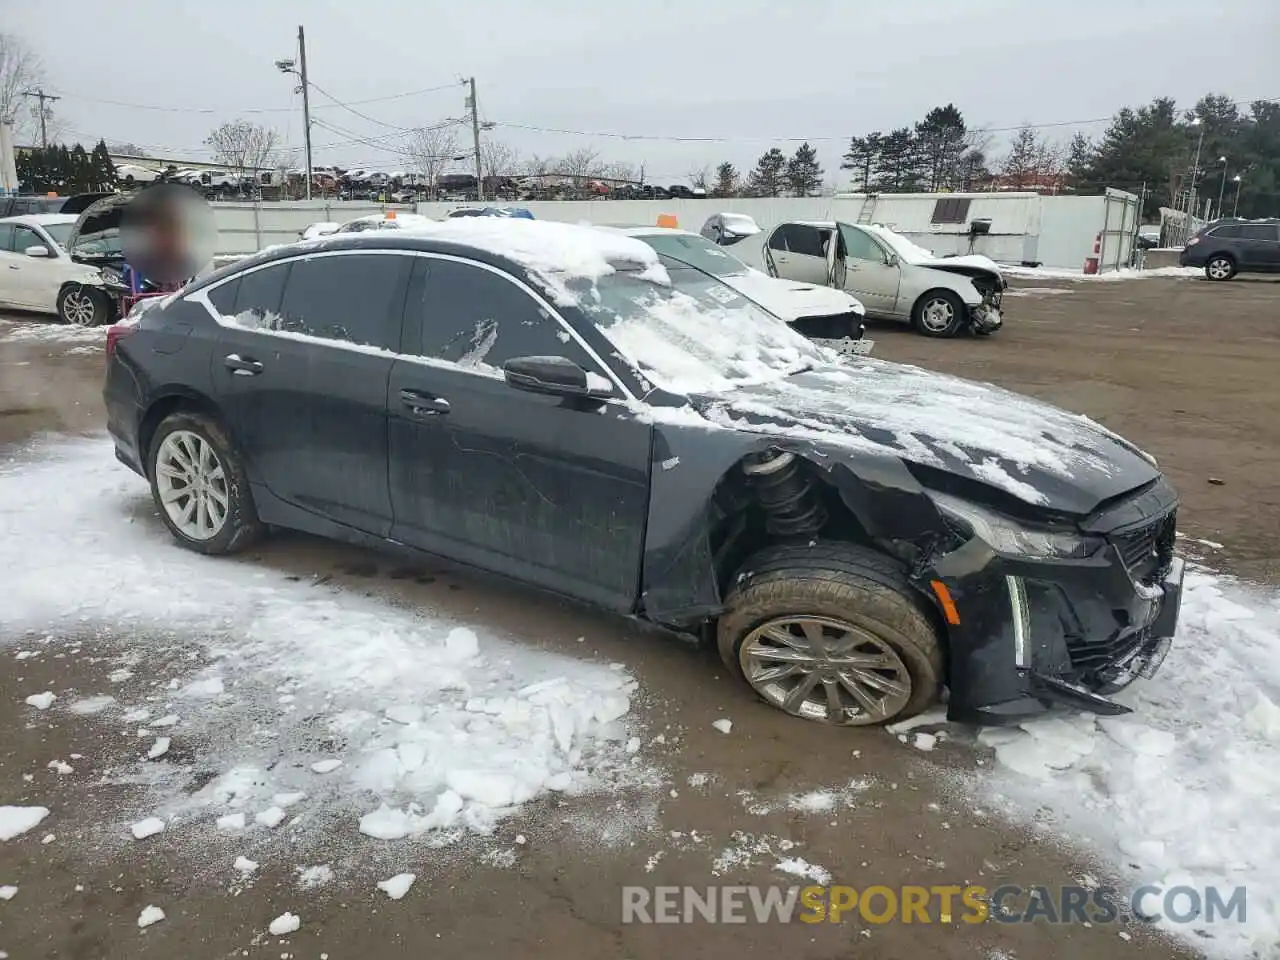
[[147, 412, 264, 554]]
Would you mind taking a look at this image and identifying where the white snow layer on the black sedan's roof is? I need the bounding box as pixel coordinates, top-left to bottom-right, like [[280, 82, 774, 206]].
[[394, 216, 668, 306]]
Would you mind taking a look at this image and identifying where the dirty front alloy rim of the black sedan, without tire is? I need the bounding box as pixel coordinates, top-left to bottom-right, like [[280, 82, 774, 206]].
[[739, 616, 911, 726]]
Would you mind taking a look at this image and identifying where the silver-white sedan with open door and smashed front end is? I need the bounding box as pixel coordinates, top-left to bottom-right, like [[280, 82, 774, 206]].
[[762, 220, 1009, 337]]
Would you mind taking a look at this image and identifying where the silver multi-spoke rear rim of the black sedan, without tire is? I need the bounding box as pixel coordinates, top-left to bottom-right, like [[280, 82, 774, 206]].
[[155, 430, 230, 540]]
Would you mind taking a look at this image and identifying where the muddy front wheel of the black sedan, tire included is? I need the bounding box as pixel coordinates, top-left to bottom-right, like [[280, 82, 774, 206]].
[[717, 543, 943, 726]]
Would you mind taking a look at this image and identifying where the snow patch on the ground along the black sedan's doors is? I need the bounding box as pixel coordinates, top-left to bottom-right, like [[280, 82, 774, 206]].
[[0, 440, 639, 838]]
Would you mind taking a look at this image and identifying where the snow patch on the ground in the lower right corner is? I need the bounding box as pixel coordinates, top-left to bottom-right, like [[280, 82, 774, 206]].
[[980, 572, 1280, 957]]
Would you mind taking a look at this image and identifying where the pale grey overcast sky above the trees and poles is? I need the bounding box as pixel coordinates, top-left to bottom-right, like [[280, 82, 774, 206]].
[[0, 0, 1280, 183]]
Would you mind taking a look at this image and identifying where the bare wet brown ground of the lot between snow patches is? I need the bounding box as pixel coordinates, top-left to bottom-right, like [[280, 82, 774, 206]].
[[0, 272, 1280, 960]]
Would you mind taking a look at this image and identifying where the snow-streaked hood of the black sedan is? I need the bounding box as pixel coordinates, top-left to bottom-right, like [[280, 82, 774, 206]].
[[694, 358, 1160, 516]]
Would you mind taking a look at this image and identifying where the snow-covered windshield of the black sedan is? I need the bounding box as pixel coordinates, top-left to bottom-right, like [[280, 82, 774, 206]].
[[581, 257, 824, 393]]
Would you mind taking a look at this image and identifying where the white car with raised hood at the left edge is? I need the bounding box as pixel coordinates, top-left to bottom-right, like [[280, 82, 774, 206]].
[[0, 214, 113, 326]]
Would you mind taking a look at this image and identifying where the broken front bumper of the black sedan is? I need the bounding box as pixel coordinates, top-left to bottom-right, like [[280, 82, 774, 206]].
[[938, 499, 1184, 724]]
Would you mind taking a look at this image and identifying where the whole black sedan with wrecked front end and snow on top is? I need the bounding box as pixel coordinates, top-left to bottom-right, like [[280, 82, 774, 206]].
[[104, 219, 1183, 724]]
